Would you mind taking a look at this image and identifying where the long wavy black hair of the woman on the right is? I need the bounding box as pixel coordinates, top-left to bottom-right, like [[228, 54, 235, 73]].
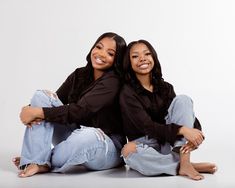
[[123, 39, 165, 94]]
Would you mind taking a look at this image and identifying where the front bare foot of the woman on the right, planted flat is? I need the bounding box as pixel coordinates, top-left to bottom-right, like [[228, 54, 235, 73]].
[[179, 163, 204, 180]]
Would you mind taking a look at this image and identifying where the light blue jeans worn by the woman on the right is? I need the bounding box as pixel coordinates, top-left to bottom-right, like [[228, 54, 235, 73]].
[[124, 95, 195, 176]]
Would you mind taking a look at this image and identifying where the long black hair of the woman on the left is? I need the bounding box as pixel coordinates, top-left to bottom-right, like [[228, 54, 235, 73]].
[[86, 32, 126, 76]]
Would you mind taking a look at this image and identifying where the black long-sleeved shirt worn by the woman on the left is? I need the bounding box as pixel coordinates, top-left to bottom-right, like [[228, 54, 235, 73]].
[[43, 68, 125, 148]]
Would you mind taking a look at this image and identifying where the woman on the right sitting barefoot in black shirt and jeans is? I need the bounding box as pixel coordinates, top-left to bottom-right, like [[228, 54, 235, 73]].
[[120, 40, 216, 180]]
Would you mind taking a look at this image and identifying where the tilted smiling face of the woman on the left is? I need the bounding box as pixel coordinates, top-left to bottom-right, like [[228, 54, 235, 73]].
[[91, 37, 116, 72]]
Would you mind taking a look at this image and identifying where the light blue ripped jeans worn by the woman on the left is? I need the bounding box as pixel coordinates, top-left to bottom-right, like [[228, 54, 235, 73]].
[[20, 90, 122, 172]]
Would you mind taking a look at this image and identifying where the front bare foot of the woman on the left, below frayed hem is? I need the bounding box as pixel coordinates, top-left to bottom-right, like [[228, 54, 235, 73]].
[[18, 164, 50, 178]]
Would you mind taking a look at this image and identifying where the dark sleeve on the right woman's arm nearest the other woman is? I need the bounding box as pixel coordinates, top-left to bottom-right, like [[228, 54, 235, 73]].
[[120, 85, 181, 145]]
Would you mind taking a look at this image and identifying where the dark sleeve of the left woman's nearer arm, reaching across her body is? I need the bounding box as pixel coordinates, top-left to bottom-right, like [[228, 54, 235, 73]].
[[43, 75, 120, 124]]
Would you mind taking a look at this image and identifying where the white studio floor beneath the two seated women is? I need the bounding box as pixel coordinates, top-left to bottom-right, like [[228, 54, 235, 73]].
[[0, 143, 235, 188]]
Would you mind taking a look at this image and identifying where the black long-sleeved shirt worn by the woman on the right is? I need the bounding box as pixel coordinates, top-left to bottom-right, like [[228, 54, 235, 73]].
[[120, 82, 201, 145]]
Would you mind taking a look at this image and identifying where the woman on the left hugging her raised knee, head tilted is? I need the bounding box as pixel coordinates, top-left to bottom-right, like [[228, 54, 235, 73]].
[[13, 32, 126, 177]]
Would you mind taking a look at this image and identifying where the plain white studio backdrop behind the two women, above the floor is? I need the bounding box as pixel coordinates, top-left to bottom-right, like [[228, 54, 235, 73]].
[[0, 0, 235, 158]]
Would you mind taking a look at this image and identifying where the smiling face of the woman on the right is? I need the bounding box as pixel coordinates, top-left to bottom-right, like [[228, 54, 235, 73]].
[[130, 43, 154, 76]]
